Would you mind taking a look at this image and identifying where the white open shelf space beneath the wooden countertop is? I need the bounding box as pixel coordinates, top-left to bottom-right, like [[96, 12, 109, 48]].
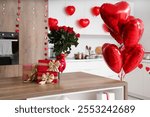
[[27, 86, 124, 100]]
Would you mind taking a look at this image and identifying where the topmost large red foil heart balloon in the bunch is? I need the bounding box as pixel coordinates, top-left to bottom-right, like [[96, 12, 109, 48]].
[[100, 1, 130, 33]]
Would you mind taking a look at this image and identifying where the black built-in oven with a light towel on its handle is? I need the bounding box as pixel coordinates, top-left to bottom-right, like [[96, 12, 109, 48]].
[[0, 32, 19, 65]]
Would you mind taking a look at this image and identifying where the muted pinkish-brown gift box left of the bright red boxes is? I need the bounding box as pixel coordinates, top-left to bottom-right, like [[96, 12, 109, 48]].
[[22, 64, 37, 81]]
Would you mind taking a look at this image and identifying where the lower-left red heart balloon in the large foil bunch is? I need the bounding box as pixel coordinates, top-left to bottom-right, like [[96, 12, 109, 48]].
[[102, 43, 122, 73]]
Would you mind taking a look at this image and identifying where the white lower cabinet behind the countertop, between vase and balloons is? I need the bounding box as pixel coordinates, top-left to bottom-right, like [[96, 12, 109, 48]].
[[64, 58, 119, 80]]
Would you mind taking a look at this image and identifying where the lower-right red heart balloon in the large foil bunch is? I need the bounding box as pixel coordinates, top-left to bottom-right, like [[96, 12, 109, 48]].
[[122, 44, 144, 74]]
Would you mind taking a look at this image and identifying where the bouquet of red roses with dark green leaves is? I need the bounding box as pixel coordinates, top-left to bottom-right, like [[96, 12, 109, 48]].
[[48, 25, 80, 56]]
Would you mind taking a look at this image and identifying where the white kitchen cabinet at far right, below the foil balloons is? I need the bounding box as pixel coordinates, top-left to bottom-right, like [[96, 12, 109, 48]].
[[125, 60, 150, 99]]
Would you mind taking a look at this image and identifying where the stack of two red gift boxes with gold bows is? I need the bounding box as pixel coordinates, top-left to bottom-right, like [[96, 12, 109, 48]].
[[37, 60, 60, 84]]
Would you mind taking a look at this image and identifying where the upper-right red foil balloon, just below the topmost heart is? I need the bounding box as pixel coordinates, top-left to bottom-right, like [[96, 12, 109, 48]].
[[122, 18, 144, 47]]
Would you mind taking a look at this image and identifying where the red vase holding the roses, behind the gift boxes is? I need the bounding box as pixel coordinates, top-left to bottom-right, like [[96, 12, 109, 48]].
[[56, 54, 66, 72]]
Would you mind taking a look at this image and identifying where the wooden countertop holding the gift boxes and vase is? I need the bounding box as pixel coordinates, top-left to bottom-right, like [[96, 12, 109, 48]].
[[0, 72, 127, 100]]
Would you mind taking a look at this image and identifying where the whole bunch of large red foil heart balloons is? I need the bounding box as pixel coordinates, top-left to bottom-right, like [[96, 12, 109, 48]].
[[100, 1, 144, 79]]
